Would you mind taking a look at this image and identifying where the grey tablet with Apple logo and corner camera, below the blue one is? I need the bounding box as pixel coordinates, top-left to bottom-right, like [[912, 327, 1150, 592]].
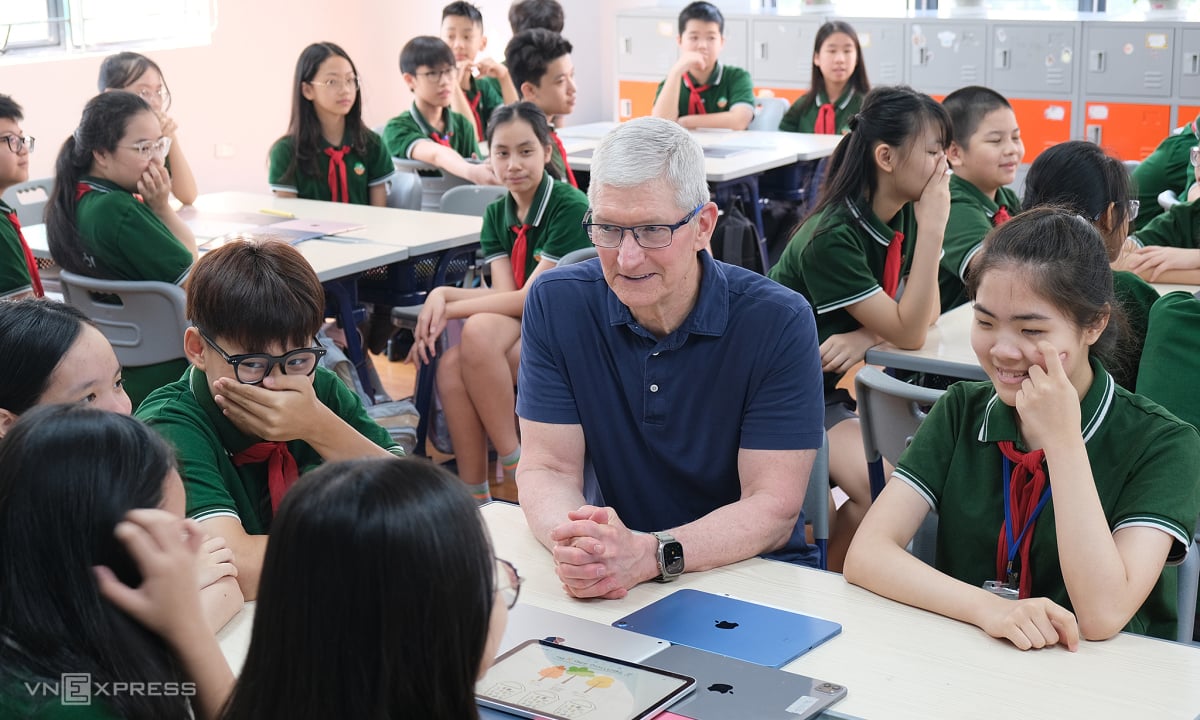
[[644, 646, 846, 720]]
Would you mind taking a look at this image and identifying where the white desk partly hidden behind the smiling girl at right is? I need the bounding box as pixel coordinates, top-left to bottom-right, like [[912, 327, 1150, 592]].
[[865, 283, 1200, 381]]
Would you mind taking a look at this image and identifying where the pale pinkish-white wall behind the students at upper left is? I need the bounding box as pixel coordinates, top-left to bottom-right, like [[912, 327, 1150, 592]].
[[0, 0, 655, 192]]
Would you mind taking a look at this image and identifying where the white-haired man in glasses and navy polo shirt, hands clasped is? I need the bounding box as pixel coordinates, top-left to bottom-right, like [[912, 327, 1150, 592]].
[[517, 118, 824, 599]]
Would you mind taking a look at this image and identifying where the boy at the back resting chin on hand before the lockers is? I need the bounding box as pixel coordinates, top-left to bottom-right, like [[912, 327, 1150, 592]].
[[650, 2, 754, 130]]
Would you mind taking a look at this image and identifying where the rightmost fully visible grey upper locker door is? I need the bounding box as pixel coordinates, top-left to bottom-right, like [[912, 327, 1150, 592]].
[[1084, 23, 1171, 97]]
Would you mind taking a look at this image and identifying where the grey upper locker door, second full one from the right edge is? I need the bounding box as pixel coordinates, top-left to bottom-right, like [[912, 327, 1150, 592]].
[[988, 22, 1084, 96]]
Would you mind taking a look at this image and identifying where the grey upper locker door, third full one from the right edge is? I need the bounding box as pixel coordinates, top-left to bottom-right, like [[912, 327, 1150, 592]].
[[908, 20, 988, 92]]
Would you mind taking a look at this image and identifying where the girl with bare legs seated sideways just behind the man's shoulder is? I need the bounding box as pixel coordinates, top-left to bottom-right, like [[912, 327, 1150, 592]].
[[409, 102, 590, 500]]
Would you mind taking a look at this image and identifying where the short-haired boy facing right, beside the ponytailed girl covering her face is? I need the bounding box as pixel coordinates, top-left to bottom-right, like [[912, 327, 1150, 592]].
[[937, 85, 1025, 312]]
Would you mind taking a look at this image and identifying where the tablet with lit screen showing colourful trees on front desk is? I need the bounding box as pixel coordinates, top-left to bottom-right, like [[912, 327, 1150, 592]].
[[475, 640, 696, 720]]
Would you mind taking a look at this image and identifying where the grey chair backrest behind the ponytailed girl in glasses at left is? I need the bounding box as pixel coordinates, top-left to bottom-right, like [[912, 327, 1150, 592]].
[[59, 270, 187, 367]]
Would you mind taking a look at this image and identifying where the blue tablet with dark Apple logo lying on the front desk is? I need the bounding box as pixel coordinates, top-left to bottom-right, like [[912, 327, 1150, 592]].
[[613, 589, 841, 667]]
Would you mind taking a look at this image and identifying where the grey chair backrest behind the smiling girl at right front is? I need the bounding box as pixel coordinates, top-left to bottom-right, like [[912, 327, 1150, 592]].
[[854, 366, 944, 498]]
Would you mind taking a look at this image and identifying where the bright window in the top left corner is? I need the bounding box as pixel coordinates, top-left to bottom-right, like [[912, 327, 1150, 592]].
[[0, 0, 216, 56]]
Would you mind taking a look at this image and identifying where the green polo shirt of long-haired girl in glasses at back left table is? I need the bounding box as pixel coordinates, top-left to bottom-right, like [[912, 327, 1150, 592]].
[[268, 130, 396, 205]]
